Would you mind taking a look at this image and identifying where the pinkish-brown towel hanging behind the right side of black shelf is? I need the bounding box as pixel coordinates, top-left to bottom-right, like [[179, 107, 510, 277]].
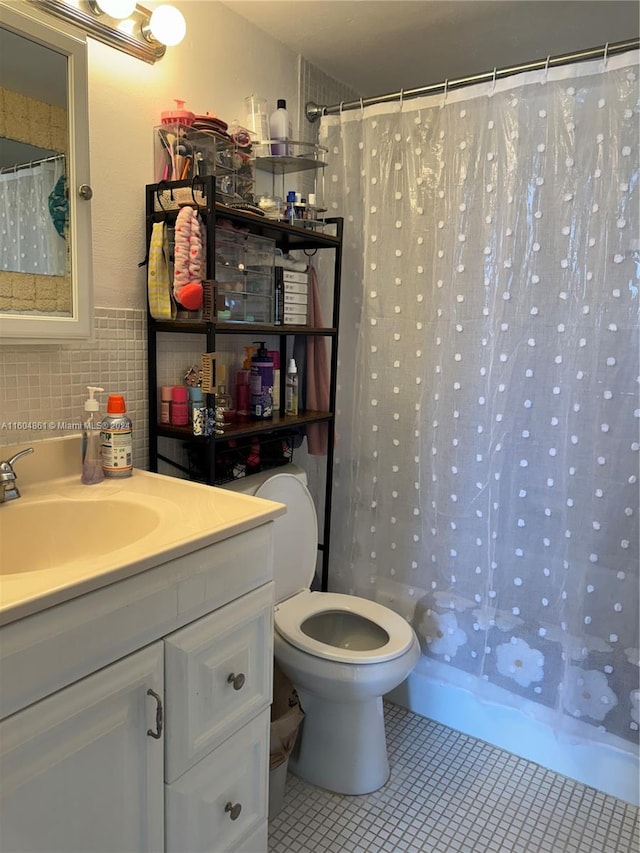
[[305, 266, 329, 456]]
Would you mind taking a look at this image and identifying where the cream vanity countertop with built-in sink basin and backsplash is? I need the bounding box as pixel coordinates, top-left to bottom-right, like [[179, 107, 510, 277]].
[[0, 435, 285, 625]]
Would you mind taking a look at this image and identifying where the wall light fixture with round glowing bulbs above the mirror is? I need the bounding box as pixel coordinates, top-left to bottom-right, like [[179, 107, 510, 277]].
[[29, 0, 187, 63]]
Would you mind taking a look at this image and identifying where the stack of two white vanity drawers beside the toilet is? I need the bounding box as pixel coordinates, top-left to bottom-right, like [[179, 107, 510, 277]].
[[165, 584, 273, 853]]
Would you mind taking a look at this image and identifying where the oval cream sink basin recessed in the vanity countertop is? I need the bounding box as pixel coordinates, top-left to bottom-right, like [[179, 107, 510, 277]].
[[0, 497, 162, 576]]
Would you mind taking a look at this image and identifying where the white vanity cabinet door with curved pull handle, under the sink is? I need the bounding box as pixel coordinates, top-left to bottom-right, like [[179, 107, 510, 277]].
[[0, 642, 165, 853]]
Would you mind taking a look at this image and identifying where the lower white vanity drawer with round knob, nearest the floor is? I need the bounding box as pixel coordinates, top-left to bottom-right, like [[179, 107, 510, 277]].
[[165, 708, 270, 853]]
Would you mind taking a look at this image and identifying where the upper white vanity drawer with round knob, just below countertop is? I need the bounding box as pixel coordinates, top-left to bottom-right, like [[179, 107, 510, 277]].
[[165, 583, 273, 784]]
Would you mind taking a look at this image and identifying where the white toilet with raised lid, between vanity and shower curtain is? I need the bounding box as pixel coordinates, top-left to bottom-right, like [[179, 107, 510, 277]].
[[226, 464, 420, 794]]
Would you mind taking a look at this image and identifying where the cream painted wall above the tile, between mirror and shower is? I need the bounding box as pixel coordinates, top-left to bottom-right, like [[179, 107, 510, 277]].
[[89, 0, 298, 308]]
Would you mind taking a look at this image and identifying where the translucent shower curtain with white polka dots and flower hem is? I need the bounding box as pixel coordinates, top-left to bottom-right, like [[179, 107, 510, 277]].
[[320, 53, 640, 740]]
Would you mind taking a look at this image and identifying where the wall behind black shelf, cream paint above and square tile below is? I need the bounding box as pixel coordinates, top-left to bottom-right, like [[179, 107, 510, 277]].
[[0, 0, 330, 460]]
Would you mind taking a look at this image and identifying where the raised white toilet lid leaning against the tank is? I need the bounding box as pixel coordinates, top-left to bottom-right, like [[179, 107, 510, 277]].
[[255, 474, 318, 602]]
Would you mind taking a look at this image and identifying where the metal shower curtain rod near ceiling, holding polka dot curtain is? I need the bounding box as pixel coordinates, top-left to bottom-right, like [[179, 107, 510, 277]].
[[306, 39, 640, 123]]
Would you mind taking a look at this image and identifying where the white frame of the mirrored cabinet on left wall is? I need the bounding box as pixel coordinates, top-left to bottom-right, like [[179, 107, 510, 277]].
[[0, 0, 93, 344]]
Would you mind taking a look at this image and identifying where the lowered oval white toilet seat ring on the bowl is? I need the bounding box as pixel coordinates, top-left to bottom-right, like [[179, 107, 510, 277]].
[[275, 590, 414, 665]]
